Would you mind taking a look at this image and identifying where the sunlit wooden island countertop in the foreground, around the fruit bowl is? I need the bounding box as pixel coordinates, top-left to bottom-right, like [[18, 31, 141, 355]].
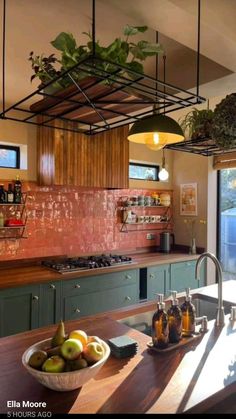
[[0, 287, 236, 413]]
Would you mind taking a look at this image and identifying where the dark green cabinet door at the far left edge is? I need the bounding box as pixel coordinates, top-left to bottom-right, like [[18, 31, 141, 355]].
[[0, 285, 40, 337]]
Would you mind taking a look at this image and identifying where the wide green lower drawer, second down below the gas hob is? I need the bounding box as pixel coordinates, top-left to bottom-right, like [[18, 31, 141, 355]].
[[63, 284, 138, 320]]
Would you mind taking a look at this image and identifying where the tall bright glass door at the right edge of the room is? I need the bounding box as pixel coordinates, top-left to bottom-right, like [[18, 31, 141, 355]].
[[218, 169, 236, 279]]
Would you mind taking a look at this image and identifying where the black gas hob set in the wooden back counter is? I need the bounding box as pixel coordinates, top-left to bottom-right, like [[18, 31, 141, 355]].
[[42, 254, 134, 274]]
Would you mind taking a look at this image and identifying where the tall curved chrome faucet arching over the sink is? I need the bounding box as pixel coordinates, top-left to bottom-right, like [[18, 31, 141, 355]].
[[195, 252, 225, 327]]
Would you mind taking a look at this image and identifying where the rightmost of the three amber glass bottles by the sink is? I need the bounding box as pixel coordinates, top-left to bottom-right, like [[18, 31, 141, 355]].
[[181, 288, 196, 336]]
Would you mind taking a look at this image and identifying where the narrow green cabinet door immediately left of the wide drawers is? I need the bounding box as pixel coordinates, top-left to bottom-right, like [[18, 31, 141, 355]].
[[39, 281, 61, 327]]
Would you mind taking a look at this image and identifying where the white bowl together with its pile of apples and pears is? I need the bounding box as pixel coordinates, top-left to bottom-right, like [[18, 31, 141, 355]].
[[22, 321, 110, 391]]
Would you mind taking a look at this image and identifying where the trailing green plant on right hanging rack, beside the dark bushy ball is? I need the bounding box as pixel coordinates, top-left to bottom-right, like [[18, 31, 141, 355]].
[[179, 108, 214, 139]]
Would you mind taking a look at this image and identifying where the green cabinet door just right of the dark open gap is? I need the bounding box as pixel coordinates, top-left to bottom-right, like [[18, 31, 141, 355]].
[[147, 264, 170, 300]]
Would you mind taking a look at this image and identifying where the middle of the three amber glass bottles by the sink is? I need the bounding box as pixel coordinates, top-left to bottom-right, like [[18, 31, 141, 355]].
[[167, 291, 182, 343]]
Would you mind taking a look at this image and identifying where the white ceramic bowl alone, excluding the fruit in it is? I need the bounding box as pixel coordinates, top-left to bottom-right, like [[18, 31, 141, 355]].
[[22, 338, 110, 391]]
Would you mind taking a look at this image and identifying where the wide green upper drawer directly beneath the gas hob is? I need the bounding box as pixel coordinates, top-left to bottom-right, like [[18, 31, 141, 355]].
[[62, 269, 138, 296]]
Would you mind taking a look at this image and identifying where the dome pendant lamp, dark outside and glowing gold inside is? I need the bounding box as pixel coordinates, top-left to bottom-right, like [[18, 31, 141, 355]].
[[128, 113, 184, 150]]
